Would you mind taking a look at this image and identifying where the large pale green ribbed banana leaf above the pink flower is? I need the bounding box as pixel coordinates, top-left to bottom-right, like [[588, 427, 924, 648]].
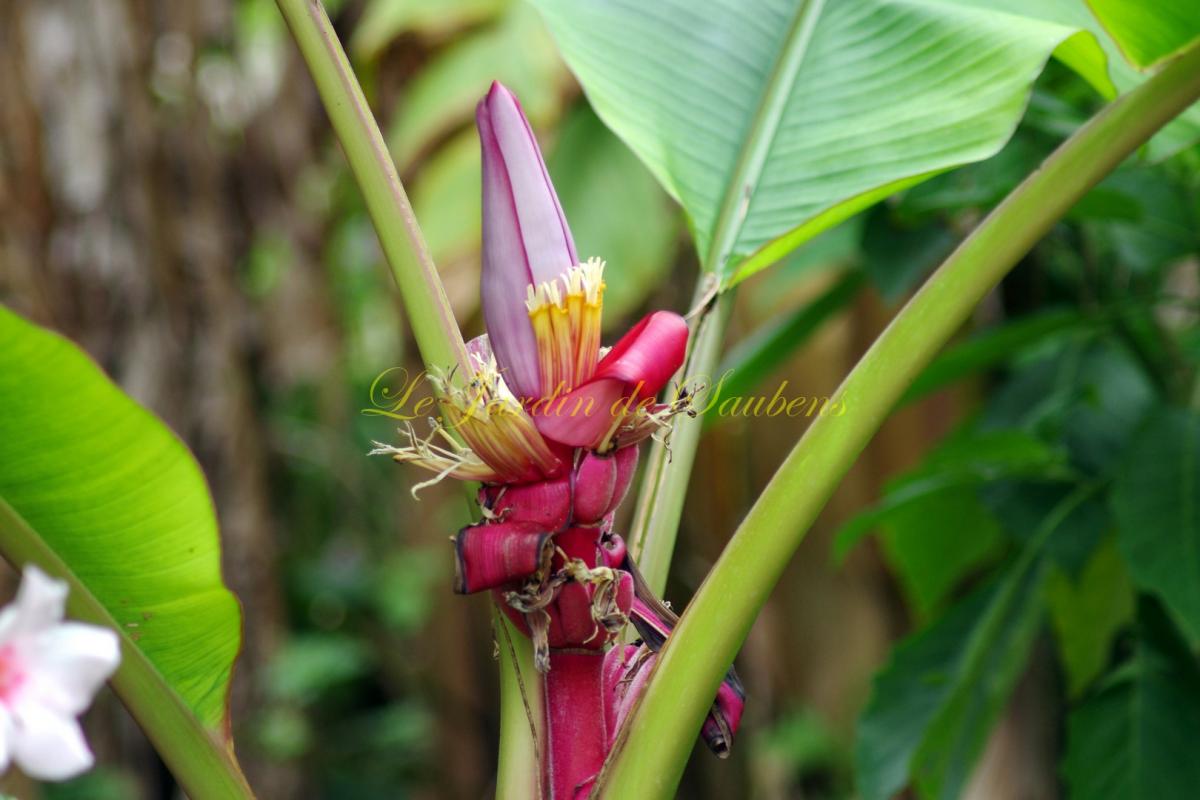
[[534, 0, 1106, 283]]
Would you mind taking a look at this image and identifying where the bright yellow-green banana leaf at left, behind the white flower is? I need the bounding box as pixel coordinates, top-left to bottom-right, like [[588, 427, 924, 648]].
[[0, 307, 244, 796]]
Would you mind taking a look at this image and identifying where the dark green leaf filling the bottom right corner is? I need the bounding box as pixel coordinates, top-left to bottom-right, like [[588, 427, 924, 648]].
[[1062, 602, 1200, 800]]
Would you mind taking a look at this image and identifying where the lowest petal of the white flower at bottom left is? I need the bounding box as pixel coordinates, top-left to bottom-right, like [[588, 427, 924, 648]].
[[12, 703, 94, 781]]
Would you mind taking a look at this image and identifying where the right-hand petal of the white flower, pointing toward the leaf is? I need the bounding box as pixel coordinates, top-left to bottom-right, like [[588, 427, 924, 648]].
[[22, 622, 121, 716]]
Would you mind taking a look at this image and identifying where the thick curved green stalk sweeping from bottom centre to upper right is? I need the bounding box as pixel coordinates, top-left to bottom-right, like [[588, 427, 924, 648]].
[[596, 40, 1200, 800]]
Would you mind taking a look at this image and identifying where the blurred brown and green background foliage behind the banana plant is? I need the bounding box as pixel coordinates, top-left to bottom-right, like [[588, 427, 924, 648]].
[[0, 0, 1200, 799]]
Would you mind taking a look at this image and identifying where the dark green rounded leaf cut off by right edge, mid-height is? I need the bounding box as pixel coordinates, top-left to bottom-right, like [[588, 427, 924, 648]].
[[1112, 408, 1200, 639]]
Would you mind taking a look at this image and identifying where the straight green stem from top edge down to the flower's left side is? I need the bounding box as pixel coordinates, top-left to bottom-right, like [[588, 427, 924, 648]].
[[276, 0, 467, 374]]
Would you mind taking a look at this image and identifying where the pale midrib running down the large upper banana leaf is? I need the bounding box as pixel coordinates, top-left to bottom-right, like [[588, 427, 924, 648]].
[[703, 0, 824, 279]]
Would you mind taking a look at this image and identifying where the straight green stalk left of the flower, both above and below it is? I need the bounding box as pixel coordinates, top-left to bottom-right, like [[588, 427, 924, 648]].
[[276, 0, 541, 800]]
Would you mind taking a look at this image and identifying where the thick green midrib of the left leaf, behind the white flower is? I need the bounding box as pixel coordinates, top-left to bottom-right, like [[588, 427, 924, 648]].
[[0, 499, 254, 800]]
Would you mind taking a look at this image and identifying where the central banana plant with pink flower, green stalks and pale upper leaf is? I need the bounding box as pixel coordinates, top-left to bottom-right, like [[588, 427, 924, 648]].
[[278, 0, 1200, 798]]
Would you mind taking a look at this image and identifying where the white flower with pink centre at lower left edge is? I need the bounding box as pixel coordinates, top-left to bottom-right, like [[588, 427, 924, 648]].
[[0, 565, 121, 781]]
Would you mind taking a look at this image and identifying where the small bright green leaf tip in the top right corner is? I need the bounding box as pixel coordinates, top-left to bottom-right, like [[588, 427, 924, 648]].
[[1087, 0, 1200, 70]]
